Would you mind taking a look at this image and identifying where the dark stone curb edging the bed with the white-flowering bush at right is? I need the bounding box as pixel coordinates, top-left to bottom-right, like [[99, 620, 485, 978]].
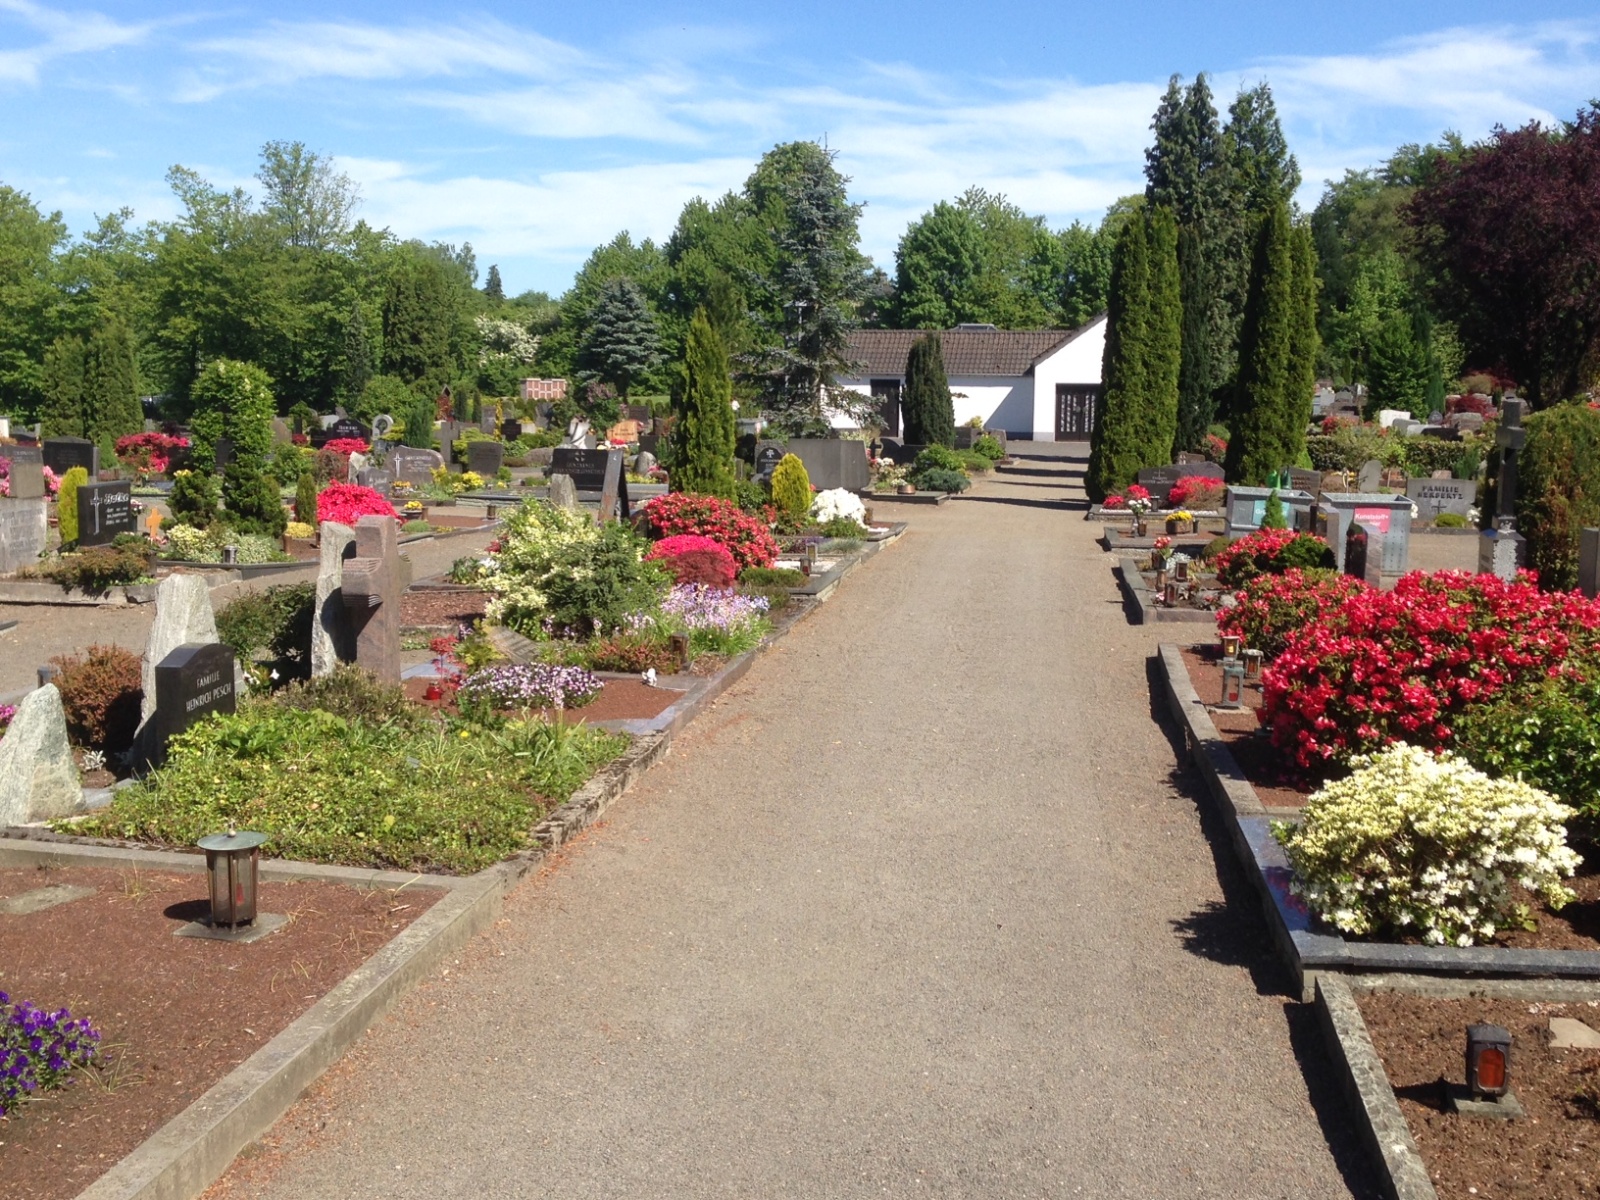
[[1160, 645, 1600, 1002]]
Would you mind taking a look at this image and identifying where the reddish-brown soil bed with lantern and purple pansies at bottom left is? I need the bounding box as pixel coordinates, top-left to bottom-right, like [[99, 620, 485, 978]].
[[0, 867, 442, 1200]]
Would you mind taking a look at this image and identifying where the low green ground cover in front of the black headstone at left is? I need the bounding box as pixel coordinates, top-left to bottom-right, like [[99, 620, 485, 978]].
[[72, 669, 627, 872]]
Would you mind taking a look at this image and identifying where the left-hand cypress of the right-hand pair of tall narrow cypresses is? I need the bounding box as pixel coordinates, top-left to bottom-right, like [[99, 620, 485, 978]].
[[1226, 202, 1309, 485]]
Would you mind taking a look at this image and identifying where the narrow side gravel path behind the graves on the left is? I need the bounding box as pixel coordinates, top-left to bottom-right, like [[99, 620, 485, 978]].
[[0, 533, 493, 699]]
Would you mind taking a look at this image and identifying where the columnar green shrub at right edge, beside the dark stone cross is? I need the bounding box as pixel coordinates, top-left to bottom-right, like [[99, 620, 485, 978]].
[[1517, 403, 1600, 592]]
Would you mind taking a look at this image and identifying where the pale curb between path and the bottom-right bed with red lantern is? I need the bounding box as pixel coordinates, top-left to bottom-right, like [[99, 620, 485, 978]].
[[1317, 976, 1438, 1200]]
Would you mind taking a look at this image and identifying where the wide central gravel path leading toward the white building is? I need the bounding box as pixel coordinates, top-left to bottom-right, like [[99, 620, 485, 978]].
[[200, 446, 1374, 1200]]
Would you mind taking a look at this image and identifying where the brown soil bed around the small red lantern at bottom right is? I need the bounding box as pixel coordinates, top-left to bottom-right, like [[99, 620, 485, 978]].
[[1357, 992, 1600, 1200]]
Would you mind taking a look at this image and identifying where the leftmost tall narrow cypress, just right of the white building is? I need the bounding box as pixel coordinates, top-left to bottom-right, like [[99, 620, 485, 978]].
[[1083, 218, 1150, 501]]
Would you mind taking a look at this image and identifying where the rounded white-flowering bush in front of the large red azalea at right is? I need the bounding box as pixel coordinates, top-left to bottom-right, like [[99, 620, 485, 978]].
[[1272, 742, 1579, 946]]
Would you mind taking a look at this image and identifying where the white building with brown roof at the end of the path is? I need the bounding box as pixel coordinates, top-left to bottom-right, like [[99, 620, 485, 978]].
[[835, 317, 1106, 442]]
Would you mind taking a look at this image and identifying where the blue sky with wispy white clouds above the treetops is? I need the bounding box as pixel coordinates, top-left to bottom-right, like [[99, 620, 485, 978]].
[[9, 0, 1600, 293]]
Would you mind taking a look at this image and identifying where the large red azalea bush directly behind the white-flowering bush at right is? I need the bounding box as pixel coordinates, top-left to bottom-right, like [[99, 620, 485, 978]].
[[1262, 571, 1600, 771]]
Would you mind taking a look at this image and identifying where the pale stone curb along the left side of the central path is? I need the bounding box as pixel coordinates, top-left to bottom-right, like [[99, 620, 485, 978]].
[[0, 499, 899, 1200]]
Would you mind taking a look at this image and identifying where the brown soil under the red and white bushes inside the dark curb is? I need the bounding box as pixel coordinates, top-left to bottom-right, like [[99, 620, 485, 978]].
[[1182, 645, 1600, 950]]
